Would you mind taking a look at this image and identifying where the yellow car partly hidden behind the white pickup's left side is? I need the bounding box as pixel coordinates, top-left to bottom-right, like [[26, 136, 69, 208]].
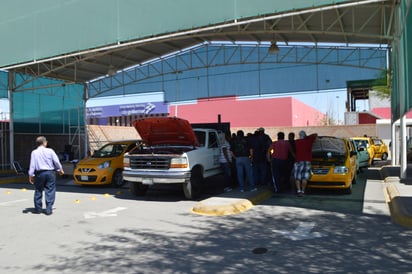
[[73, 140, 141, 187]]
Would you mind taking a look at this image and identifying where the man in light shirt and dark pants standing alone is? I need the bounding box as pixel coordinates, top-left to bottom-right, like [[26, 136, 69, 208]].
[[29, 136, 64, 215]]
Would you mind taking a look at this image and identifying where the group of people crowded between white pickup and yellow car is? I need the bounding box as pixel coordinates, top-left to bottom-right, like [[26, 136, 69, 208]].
[[221, 128, 317, 196]]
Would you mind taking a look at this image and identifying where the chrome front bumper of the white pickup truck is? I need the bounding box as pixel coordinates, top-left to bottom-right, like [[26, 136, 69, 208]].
[[123, 170, 191, 185]]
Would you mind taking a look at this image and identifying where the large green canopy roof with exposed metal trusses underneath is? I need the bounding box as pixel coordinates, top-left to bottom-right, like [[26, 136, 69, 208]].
[[0, 0, 397, 83]]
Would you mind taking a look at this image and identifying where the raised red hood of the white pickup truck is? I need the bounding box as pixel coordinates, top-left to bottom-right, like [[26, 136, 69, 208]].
[[132, 117, 199, 146]]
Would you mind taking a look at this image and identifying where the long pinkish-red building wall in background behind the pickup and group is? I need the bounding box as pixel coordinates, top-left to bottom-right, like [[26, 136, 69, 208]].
[[169, 97, 324, 127]]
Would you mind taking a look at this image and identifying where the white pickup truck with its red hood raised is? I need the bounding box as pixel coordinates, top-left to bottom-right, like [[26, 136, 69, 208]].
[[123, 117, 222, 199]]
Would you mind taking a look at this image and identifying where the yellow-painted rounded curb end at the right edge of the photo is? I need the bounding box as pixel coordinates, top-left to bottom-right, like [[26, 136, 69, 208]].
[[386, 184, 412, 228]]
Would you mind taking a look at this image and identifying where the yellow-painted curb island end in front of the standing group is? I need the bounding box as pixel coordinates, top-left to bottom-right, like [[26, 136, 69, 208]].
[[192, 190, 272, 216]]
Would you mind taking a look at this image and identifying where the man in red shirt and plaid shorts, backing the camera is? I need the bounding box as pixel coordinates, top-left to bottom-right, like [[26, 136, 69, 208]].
[[294, 130, 318, 197]]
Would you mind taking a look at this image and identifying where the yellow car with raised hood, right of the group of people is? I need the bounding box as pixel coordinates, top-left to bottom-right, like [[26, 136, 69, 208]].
[[308, 136, 358, 194]]
